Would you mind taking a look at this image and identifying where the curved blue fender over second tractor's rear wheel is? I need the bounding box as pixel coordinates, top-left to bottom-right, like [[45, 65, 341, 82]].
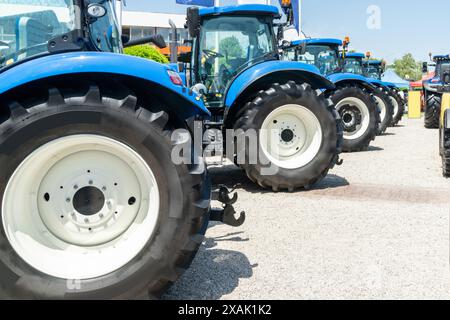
[[225, 60, 334, 108]]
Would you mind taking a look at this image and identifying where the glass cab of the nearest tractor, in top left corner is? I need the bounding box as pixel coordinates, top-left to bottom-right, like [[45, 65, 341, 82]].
[[0, 0, 122, 69]]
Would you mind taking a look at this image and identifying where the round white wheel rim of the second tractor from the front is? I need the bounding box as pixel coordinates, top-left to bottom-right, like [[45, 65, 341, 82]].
[[259, 104, 323, 169]]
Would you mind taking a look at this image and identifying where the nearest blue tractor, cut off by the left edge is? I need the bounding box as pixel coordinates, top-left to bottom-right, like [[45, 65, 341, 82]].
[[0, 0, 243, 299]]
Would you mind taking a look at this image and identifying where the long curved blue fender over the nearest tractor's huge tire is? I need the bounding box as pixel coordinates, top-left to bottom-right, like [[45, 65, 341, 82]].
[[0, 52, 210, 119]]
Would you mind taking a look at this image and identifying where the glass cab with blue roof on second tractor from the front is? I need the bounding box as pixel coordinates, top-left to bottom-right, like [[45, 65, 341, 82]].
[[187, 5, 279, 107]]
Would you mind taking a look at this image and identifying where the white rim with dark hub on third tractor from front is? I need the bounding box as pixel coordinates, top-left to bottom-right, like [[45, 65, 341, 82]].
[[336, 97, 370, 140]]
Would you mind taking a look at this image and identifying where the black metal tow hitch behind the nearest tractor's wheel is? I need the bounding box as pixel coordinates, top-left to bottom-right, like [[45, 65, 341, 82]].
[[210, 186, 245, 227]]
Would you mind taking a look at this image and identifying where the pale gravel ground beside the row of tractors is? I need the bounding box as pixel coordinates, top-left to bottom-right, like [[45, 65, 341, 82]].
[[165, 120, 450, 299]]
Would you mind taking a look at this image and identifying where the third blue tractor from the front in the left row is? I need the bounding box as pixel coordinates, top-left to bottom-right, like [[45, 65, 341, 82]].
[[282, 39, 380, 152]]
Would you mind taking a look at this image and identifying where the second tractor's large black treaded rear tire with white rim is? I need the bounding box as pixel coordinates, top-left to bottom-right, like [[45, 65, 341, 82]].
[[234, 81, 343, 192]]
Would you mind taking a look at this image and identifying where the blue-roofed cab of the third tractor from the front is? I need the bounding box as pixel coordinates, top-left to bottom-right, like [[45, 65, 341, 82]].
[[283, 39, 342, 76]]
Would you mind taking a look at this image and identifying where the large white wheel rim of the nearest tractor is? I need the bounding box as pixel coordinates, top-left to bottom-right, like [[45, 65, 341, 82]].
[[2, 135, 160, 280]]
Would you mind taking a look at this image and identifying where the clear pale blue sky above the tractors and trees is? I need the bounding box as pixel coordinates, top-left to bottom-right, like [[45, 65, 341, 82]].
[[126, 0, 450, 62]]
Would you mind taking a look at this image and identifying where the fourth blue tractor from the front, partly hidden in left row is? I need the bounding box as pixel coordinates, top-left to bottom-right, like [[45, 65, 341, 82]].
[[342, 51, 395, 134]]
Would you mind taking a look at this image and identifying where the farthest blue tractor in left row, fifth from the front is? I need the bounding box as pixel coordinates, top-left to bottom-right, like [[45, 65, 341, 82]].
[[364, 58, 407, 127]]
